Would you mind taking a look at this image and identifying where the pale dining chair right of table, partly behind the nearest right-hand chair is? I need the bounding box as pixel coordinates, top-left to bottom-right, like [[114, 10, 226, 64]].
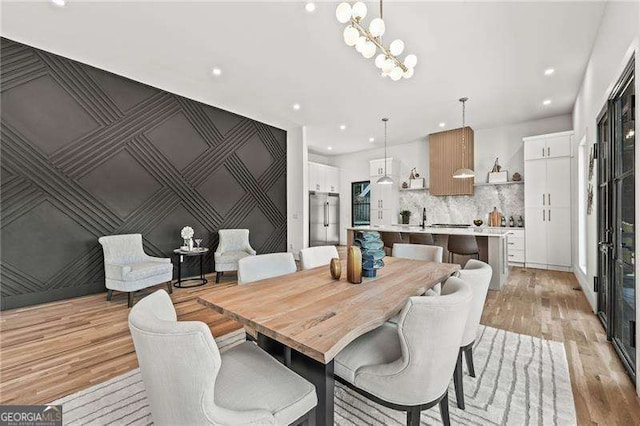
[[452, 259, 493, 410]]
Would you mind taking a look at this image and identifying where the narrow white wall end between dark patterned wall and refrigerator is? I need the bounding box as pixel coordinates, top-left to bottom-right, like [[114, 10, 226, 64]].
[[287, 127, 309, 257]]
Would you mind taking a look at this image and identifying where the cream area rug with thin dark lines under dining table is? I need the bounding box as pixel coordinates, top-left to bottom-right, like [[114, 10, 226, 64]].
[[53, 326, 576, 426]]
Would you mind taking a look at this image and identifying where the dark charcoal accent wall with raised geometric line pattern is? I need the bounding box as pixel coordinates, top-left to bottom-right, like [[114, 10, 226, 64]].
[[0, 38, 287, 309]]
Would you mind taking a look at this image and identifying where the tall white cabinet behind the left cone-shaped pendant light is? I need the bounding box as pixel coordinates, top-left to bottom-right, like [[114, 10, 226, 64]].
[[369, 158, 400, 226]]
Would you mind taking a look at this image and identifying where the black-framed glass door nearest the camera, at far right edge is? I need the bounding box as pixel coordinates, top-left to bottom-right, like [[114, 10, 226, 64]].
[[611, 63, 636, 375]]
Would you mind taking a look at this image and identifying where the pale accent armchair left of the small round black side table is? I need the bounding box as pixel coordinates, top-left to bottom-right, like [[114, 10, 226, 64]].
[[98, 234, 173, 307]]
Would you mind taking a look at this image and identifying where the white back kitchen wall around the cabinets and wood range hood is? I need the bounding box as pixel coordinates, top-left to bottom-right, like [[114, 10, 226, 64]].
[[330, 114, 572, 244]]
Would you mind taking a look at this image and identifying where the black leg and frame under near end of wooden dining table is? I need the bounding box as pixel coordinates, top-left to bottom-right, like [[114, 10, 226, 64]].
[[258, 334, 335, 426]]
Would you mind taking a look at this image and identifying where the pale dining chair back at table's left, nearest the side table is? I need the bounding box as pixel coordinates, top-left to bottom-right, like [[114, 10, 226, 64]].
[[238, 253, 297, 284]]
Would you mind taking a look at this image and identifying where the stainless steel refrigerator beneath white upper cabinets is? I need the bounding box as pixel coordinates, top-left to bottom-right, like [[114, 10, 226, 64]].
[[309, 192, 340, 247]]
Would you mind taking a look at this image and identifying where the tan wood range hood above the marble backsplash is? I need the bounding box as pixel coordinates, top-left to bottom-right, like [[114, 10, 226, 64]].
[[428, 126, 475, 195]]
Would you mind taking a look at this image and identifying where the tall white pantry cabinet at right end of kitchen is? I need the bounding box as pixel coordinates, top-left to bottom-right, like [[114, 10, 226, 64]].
[[524, 131, 573, 271]]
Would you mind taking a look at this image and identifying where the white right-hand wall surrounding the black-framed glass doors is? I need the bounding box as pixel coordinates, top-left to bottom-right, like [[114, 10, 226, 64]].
[[573, 2, 640, 395]]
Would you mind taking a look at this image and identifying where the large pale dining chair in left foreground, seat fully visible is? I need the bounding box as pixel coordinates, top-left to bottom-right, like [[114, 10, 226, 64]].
[[129, 290, 317, 425]]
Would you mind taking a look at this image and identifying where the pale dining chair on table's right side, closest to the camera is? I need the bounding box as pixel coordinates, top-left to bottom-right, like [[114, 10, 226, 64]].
[[334, 277, 473, 426]]
